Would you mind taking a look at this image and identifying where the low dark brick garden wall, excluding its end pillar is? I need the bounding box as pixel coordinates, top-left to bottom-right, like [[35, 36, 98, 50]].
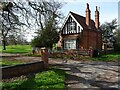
[[2, 61, 44, 79]]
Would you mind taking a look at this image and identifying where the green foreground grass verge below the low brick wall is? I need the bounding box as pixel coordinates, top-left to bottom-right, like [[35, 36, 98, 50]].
[[2, 68, 66, 90]]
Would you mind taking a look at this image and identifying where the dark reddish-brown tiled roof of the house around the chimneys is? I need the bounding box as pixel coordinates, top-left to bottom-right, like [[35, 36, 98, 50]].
[[70, 11, 96, 30]]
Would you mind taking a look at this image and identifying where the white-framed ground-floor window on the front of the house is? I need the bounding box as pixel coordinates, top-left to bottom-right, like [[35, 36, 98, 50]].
[[64, 39, 76, 50]]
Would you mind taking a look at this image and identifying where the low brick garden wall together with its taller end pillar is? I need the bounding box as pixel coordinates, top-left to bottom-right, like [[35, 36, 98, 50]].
[[0, 48, 48, 79]]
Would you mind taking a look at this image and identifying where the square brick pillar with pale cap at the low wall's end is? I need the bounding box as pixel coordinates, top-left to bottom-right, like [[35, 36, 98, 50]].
[[41, 48, 48, 68]]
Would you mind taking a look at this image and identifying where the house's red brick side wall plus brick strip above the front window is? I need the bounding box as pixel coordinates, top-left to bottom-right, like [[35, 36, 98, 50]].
[[60, 29, 102, 50]]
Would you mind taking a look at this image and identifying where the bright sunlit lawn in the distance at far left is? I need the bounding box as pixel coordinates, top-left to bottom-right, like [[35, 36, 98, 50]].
[[0, 45, 32, 53]]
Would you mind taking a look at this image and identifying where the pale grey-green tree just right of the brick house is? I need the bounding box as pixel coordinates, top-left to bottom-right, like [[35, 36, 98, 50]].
[[101, 19, 117, 52]]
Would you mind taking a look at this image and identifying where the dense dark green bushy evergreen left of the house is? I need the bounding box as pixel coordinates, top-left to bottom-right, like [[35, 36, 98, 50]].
[[32, 19, 58, 48]]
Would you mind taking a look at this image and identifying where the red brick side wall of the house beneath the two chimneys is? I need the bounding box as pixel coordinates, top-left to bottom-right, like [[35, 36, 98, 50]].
[[79, 30, 102, 50]]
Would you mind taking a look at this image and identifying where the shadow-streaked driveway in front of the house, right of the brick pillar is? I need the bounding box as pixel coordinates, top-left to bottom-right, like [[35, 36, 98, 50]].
[[50, 59, 120, 90]]
